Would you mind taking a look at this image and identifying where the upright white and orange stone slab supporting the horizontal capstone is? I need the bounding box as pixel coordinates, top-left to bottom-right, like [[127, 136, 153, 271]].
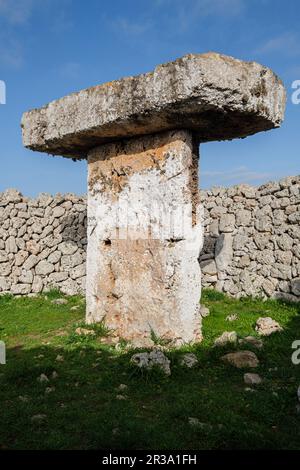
[[87, 131, 202, 344]]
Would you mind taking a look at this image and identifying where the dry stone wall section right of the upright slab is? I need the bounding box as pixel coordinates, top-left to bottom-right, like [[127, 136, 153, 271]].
[[200, 176, 300, 300]]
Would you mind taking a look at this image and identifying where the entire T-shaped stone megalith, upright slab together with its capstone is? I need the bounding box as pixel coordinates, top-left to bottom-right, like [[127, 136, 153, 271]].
[[22, 53, 285, 345]]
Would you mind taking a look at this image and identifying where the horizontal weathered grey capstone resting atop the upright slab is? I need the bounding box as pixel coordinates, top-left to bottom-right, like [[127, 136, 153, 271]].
[[22, 53, 285, 157]]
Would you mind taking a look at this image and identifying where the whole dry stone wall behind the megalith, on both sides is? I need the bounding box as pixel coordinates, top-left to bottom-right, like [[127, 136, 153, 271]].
[[0, 176, 300, 300]]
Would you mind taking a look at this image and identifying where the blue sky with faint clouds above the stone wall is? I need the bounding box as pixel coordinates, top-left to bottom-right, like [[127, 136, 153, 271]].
[[0, 0, 300, 196]]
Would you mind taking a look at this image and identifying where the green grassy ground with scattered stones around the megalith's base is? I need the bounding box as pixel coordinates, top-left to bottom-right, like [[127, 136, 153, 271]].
[[0, 291, 300, 449]]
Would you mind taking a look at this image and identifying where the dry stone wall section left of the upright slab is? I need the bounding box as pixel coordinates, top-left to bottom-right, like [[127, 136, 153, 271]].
[[0, 189, 87, 295]]
